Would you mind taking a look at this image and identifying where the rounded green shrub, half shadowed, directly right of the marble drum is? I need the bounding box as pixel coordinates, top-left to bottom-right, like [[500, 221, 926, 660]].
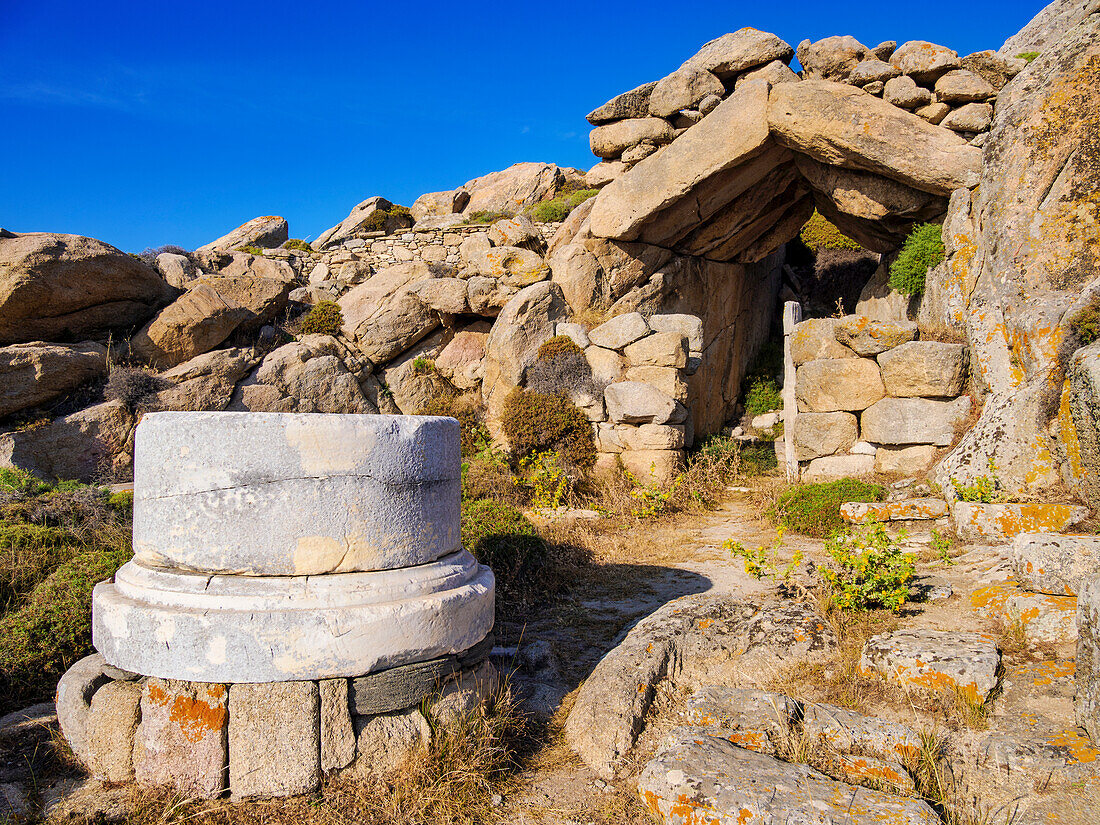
[[462, 498, 545, 601]]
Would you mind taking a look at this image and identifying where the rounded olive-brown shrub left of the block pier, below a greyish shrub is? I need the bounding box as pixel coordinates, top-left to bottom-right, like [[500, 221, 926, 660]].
[[501, 387, 596, 471]]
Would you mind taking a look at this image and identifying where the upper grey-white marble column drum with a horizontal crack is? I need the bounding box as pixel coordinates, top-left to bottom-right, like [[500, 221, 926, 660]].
[[134, 413, 461, 575]]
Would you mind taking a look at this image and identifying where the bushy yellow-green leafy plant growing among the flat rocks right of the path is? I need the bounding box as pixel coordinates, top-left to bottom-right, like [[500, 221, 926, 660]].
[[817, 521, 915, 613]]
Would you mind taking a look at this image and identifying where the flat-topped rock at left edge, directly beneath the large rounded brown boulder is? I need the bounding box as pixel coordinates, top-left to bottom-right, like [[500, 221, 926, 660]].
[[0, 341, 107, 417]]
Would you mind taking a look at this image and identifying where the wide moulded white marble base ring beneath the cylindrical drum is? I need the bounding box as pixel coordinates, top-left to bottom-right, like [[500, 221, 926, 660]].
[[92, 550, 494, 683]]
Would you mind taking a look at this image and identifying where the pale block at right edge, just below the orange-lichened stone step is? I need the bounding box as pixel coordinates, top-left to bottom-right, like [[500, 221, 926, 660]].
[[1012, 532, 1100, 596]]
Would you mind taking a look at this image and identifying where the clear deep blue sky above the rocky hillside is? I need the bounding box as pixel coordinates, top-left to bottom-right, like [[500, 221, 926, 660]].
[[0, 0, 1042, 251]]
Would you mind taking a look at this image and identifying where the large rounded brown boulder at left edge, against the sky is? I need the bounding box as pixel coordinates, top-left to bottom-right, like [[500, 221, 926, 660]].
[[0, 232, 176, 344]]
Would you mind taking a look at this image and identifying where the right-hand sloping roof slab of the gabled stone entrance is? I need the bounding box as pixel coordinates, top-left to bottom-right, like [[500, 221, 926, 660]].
[[765, 80, 981, 195]]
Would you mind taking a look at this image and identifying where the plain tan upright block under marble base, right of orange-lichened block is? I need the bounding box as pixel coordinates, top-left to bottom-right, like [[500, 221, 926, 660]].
[[229, 682, 321, 799]]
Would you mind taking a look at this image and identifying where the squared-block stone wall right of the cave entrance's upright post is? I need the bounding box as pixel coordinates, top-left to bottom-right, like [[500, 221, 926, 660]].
[[784, 316, 971, 481]]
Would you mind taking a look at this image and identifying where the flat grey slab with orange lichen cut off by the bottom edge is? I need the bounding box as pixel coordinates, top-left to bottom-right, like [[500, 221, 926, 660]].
[[638, 729, 939, 825]]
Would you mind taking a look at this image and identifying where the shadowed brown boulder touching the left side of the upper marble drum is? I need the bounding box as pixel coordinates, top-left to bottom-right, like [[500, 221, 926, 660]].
[[0, 402, 134, 482]]
